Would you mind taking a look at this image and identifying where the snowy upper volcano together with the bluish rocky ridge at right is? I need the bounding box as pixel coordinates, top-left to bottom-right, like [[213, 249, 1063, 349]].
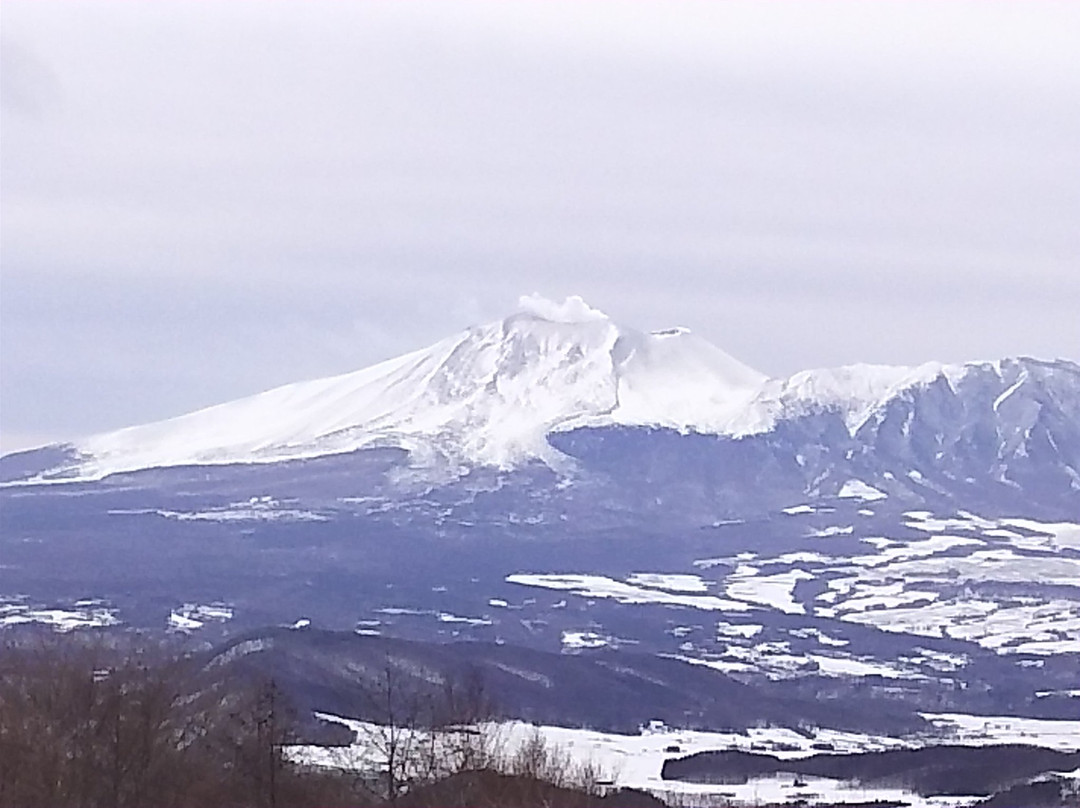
[[3, 296, 1080, 499]]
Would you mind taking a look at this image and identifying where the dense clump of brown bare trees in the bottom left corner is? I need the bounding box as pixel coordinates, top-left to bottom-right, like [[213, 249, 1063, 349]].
[[0, 637, 328, 808]]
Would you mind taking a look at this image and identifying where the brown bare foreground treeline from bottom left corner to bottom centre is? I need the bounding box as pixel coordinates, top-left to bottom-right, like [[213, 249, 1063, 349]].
[[0, 636, 657, 808]]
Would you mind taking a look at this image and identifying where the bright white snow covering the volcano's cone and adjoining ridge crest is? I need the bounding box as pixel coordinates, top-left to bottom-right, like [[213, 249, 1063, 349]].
[[14, 295, 993, 483]]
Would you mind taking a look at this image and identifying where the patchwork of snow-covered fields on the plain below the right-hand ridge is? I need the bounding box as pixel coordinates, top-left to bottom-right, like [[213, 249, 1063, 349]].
[[507, 507, 1080, 679]]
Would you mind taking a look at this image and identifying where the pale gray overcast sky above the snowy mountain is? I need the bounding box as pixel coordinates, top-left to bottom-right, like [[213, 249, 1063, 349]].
[[0, 0, 1080, 450]]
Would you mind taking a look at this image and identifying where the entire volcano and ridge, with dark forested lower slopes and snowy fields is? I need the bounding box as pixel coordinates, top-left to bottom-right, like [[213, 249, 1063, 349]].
[[0, 298, 1080, 730]]
